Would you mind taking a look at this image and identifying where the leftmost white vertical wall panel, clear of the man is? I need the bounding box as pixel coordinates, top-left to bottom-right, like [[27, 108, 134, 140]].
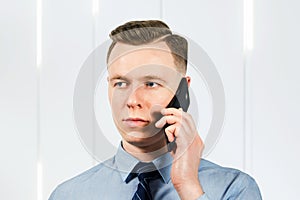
[[0, 0, 37, 200]]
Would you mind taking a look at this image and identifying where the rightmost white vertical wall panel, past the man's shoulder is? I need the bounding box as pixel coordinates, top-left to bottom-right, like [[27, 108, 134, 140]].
[[249, 0, 300, 199]]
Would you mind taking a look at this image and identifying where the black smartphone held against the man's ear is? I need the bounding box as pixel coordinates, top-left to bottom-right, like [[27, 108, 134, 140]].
[[163, 78, 190, 152]]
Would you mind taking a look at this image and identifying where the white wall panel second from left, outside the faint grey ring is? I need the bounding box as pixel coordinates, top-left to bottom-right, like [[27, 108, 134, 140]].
[[40, 0, 93, 199]]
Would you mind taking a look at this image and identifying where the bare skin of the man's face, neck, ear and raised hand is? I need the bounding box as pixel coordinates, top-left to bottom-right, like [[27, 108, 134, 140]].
[[107, 42, 204, 199]]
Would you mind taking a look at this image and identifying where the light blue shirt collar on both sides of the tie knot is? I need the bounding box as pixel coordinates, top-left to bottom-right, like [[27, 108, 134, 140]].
[[115, 143, 173, 183]]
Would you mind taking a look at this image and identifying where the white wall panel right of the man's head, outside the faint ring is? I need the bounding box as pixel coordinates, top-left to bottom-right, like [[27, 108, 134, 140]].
[[163, 0, 244, 169]]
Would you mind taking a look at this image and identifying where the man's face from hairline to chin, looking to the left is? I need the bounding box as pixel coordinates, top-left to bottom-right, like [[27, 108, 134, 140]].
[[108, 43, 182, 146]]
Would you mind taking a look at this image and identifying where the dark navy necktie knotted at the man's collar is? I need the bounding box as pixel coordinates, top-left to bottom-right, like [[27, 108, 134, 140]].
[[126, 162, 161, 200]]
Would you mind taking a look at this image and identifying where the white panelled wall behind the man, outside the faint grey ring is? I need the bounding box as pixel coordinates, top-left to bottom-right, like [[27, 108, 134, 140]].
[[0, 0, 300, 200]]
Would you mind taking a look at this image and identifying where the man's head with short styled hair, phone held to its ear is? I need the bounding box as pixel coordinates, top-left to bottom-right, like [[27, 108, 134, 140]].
[[107, 20, 190, 152]]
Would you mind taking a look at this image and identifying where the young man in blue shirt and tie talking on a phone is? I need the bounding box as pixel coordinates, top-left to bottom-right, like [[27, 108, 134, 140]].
[[50, 20, 261, 200]]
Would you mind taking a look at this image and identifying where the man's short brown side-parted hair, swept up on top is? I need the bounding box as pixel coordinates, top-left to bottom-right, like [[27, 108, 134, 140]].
[[106, 20, 188, 74]]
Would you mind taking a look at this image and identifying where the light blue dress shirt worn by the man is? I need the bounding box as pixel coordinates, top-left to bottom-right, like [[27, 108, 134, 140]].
[[49, 145, 261, 200]]
